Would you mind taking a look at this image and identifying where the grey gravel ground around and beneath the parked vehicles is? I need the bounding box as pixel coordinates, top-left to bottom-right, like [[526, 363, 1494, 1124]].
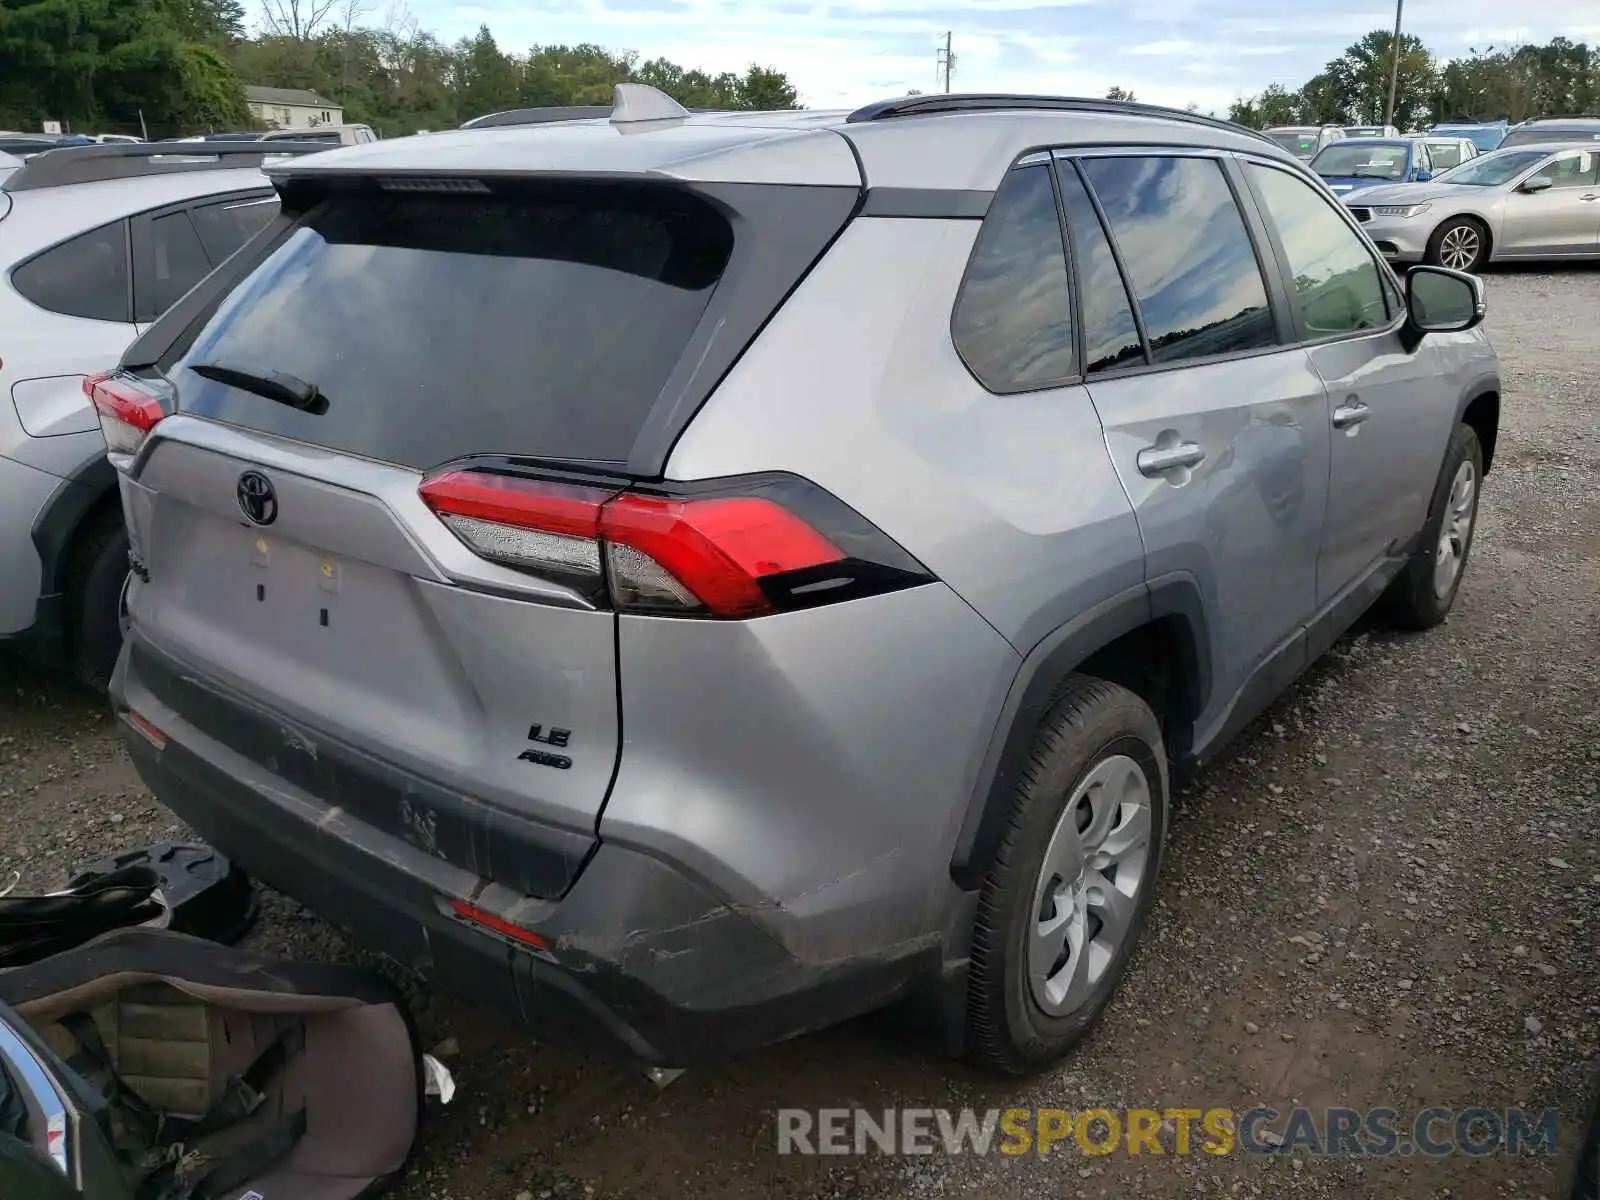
[[0, 269, 1600, 1200]]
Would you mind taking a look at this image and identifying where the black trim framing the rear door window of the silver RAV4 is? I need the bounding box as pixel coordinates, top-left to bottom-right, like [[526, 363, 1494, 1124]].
[[1053, 146, 1298, 379]]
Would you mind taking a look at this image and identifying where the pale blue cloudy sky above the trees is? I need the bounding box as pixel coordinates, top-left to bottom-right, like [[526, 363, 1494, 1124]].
[[405, 0, 1600, 110]]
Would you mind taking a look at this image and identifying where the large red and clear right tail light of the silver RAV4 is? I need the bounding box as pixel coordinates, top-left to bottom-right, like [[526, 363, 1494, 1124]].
[[421, 470, 931, 619]]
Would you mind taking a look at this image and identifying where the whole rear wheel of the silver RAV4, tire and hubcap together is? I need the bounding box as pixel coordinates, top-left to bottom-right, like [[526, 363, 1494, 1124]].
[[966, 675, 1166, 1074]]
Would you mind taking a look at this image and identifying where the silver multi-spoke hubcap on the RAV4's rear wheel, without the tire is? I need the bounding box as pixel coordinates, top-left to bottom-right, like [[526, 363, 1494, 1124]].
[[1027, 754, 1152, 1018]]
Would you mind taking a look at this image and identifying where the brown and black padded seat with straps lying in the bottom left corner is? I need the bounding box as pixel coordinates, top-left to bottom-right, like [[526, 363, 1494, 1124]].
[[0, 930, 421, 1200]]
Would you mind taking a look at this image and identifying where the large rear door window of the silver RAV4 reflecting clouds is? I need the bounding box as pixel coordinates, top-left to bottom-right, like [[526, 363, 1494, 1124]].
[[1083, 157, 1277, 362]]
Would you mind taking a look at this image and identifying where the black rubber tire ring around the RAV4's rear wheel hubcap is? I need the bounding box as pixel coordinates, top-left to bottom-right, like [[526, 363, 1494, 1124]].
[[966, 675, 1168, 1074]]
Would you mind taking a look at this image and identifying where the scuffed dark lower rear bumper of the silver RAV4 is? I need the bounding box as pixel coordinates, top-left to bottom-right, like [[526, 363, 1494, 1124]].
[[112, 640, 941, 1067]]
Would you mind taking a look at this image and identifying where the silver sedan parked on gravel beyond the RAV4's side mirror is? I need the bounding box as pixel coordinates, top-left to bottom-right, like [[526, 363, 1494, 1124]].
[[1350, 144, 1600, 270]]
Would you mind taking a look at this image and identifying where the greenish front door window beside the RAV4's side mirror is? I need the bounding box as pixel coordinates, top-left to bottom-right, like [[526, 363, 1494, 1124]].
[[1250, 166, 1389, 338]]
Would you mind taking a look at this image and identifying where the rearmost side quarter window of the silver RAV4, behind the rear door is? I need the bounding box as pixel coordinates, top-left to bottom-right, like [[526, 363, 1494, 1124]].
[[950, 165, 1077, 392]]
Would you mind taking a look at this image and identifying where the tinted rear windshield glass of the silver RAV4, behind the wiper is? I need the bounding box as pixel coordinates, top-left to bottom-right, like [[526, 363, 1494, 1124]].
[[174, 187, 733, 469]]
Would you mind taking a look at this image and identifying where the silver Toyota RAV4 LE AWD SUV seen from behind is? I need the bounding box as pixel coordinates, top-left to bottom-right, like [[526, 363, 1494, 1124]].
[[100, 88, 1501, 1070]]
